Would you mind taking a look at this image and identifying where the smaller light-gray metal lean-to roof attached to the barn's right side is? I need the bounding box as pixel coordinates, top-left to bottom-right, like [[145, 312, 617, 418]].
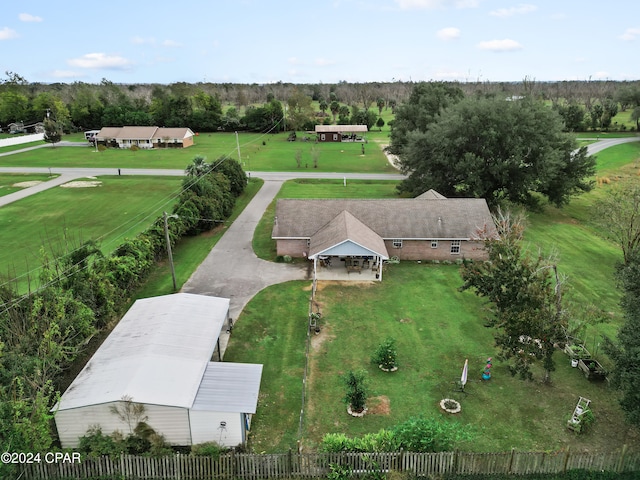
[[191, 362, 262, 413]]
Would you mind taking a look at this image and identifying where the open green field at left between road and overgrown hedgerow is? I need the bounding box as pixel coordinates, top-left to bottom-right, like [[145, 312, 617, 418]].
[[0, 176, 181, 288]]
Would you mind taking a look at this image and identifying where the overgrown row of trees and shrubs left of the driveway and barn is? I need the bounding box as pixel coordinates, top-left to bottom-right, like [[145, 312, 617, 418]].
[[0, 157, 247, 478]]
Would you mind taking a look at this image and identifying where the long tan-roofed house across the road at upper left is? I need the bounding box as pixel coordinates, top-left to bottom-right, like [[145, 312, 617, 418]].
[[95, 127, 195, 149]]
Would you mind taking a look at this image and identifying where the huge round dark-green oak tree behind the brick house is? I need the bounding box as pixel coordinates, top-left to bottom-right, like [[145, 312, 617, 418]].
[[392, 97, 595, 206]]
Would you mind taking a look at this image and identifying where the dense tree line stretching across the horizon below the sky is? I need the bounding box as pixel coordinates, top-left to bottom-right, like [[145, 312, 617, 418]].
[[0, 72, 640, 137]]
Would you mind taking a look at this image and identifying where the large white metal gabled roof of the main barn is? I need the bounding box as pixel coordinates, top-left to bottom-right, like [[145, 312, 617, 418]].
[[57, 293, 229, 410]]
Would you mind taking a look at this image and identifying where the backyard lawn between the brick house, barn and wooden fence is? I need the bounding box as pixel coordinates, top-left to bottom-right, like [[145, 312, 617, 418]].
[[225, 262, 640, 452]]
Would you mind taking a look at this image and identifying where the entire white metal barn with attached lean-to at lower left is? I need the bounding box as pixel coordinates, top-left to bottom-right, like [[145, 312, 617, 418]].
[[52, 293, 262, 448]]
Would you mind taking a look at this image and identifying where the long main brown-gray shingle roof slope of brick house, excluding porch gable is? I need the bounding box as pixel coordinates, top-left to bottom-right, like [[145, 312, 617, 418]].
[[272, 198, 493, 240]]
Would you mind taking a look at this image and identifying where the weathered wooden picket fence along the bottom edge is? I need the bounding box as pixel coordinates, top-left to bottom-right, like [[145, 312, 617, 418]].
[[20, 448, 640, 480]]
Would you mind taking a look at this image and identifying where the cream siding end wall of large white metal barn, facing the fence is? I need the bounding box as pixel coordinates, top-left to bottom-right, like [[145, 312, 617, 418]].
[[55, 402, 191, 448]]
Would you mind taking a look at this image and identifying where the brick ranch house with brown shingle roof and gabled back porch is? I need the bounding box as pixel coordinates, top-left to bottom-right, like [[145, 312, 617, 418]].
[[271, 190, 494, 280]]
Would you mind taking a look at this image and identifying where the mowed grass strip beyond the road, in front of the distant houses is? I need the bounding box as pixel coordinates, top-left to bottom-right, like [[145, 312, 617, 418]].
[[0, 133, 397, 173]]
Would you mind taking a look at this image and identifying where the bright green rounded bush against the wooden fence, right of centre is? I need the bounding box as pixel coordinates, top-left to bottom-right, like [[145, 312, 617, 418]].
[[391, 416, 472, 452]]
